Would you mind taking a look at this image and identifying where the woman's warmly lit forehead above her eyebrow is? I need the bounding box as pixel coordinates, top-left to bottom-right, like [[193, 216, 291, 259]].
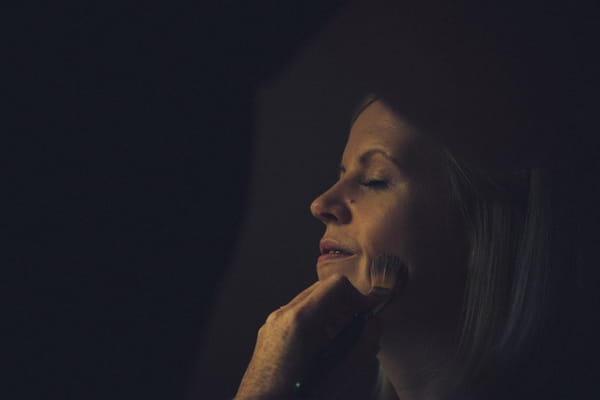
[[343, 101, 428, 161]]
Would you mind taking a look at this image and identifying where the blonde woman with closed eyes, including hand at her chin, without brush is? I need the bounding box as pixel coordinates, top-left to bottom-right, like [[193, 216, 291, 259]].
[[236, 98, 592, 400]]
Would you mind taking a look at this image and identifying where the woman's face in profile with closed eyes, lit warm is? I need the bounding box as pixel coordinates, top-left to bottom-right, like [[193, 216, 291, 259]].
[[311, 101, 467, 328]]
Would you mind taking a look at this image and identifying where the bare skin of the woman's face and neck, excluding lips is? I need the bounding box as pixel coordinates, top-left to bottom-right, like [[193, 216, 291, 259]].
[[311, 101, 467, 398]]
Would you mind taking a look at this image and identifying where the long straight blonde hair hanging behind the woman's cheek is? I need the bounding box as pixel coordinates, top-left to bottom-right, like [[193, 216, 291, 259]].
[[447, 153, 559, 392]]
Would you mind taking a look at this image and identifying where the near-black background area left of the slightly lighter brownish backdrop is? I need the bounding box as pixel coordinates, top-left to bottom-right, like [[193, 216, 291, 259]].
[[1, 1, 344, 399]]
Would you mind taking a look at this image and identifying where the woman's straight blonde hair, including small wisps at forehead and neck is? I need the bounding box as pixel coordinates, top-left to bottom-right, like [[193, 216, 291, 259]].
[[352, 95, 576, 399]]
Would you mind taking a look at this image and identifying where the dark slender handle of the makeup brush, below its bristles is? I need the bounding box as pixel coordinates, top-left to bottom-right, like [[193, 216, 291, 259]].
[[294, 313, 368, 397]]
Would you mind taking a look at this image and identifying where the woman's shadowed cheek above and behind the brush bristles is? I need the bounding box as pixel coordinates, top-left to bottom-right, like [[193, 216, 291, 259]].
[[364, 197, 467, 319]]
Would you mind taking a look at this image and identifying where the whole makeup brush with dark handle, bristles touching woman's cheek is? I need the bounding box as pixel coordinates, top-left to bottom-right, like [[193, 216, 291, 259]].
[[294, 255, 408, 397]]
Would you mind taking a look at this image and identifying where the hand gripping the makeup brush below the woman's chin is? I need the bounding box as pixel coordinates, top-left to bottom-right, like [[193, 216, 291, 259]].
[[235, 275, 381, 400]]
